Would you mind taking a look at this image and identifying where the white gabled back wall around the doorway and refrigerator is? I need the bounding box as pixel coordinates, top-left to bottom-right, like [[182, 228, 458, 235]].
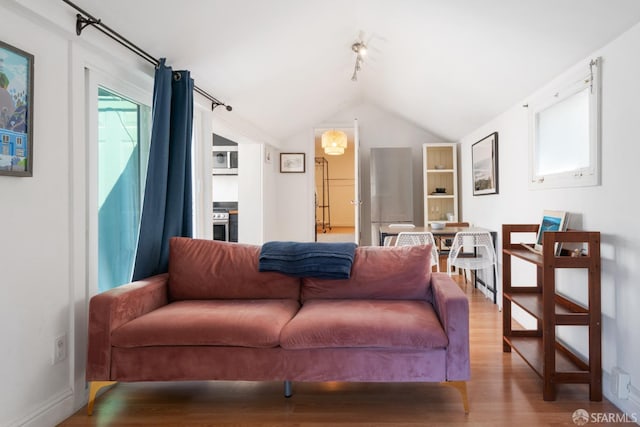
[[277, 102, 445, 245]]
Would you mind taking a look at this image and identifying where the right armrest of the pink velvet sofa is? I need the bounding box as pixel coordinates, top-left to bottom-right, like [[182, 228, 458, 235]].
[[431, 273, 471, 381]]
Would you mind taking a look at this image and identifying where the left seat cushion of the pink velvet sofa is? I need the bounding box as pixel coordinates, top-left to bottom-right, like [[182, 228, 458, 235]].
[[111, 299, 300, 348]]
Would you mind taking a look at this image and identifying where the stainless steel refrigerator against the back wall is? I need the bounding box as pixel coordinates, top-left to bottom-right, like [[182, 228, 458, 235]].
[[370, 147, 413, 245]]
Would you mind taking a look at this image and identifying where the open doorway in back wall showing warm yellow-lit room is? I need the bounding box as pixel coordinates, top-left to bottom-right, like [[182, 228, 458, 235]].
[[313, 127, 359, 243]]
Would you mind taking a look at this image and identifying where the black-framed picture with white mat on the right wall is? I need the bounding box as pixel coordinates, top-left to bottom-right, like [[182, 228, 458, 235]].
[[471, 132, 498, 196]]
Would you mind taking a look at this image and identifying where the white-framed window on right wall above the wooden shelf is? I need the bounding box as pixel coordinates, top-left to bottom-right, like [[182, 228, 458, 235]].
[[529, 59, 600, 188]]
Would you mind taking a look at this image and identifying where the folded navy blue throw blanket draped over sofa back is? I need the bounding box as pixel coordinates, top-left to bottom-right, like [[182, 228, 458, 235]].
[[258, 242, 356, 279]]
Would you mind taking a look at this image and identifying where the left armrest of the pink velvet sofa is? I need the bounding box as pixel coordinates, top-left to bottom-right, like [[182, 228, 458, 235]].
[[86, 273, 169, 381]]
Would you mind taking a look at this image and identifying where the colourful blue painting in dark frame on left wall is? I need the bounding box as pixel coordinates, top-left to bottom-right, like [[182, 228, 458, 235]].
[[0, 41, 33, 176]]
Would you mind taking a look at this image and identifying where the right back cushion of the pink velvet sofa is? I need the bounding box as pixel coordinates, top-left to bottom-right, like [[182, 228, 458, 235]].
[[301, 245, 431, 302]]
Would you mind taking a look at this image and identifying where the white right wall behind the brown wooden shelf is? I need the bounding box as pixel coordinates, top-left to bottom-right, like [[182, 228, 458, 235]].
[[460, 20, 640, 414]]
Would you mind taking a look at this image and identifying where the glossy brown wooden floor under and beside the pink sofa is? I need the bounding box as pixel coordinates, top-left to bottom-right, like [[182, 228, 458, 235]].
[[60, 280, 629, 427]]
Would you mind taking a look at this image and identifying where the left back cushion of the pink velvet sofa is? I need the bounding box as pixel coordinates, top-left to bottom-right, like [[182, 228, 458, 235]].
[[169, 237, 300, 301]]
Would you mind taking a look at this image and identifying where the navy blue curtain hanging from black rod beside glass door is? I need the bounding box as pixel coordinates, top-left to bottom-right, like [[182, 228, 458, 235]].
[[133, 58, 193, 280]]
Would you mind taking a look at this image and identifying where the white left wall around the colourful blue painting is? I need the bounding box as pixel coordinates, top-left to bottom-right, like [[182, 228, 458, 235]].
[[0, 4, 72, 426]]
